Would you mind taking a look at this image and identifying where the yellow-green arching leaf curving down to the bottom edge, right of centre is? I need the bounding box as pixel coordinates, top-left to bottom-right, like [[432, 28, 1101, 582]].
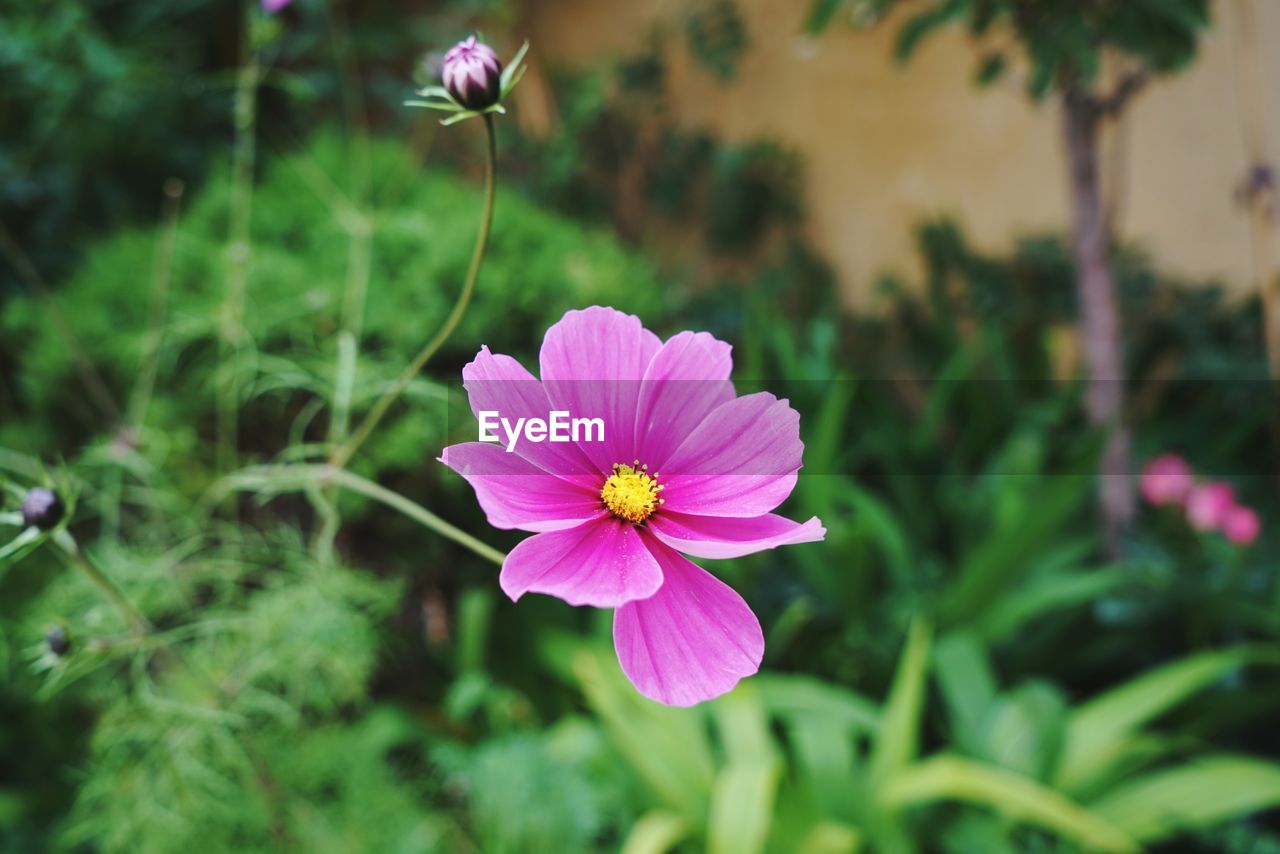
[[881, 757, 1139, 851]]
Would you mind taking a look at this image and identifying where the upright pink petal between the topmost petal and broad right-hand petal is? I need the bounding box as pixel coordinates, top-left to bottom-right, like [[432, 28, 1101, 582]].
[[636, 332, 733, 471]]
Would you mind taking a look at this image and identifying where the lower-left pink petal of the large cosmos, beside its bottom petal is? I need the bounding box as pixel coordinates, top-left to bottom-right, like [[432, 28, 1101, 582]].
[[498, 511, 662, 608]]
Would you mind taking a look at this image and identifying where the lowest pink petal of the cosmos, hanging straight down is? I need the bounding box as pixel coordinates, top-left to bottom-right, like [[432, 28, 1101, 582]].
[[616, 534, 764, 705]]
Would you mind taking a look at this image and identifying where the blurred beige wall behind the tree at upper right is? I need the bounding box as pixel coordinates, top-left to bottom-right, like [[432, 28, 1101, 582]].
[[527, 0, 1280, 303]]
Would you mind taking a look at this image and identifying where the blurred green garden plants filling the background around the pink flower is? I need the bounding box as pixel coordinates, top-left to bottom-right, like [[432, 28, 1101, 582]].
[[0, 0, 1280, 854]]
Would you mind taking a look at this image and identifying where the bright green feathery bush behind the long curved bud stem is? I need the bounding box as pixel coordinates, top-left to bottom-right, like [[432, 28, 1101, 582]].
[[0, 134, 660, 467]]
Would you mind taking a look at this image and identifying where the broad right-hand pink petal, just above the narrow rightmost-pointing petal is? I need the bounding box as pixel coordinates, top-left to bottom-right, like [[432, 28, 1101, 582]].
[[659, 392, 804, 516]]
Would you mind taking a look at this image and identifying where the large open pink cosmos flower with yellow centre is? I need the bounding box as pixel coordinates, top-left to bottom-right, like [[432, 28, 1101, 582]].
[[440, 307, 826, 705]]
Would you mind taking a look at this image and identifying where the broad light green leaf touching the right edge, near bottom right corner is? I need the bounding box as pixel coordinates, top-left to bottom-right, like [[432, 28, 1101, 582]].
[[1092, 755, 1280, 844]]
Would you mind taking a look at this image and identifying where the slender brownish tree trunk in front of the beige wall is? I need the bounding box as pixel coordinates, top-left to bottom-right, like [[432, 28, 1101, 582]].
[[1062, 92, 1134, 556]]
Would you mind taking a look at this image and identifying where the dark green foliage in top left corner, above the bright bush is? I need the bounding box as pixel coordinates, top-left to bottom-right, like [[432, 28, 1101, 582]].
[[0, 0, 435, 302]]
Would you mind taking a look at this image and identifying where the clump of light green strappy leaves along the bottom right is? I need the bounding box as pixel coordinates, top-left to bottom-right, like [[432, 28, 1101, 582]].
[[556, 625, 1280, 851]]
